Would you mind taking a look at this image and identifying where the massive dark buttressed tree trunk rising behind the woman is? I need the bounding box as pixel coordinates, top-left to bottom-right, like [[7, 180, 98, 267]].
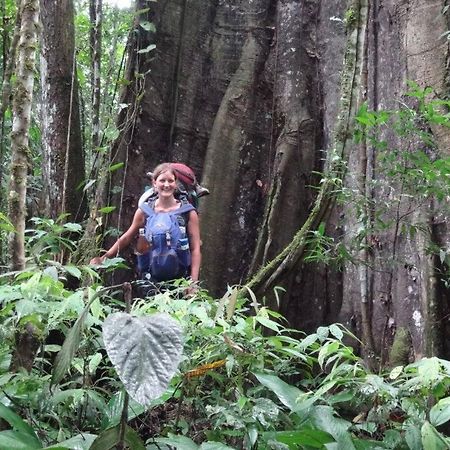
[[105, 0, 450, 362]]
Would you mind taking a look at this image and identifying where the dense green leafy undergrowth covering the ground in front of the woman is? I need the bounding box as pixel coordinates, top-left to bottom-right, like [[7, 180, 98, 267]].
[[0, 220, 450, 450]]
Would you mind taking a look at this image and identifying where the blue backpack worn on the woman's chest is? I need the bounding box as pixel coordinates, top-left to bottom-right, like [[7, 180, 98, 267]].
[[139, 202, 195, 281]]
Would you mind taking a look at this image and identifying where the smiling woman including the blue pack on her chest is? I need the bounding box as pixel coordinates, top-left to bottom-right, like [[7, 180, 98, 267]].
[[91, 163, 201, 283]]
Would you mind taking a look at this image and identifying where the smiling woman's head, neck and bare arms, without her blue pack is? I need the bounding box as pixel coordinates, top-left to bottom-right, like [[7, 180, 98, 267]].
[[91, 163, 201, 282]]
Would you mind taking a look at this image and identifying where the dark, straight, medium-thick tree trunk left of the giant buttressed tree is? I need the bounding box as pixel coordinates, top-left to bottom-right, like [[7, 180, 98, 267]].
[[41, 0, 86, 221]]
